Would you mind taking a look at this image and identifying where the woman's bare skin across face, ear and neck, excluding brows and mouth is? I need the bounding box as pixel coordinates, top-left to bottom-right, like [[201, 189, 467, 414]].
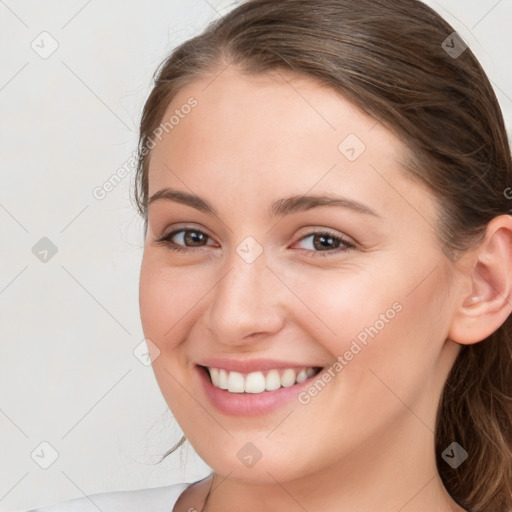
[[140, 66, 512, 512]]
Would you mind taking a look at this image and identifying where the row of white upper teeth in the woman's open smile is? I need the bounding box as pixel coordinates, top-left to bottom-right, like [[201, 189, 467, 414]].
[[208, 367, 316, 393]]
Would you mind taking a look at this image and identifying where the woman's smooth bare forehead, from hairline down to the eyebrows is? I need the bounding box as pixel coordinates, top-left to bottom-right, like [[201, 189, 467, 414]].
[[145, 67, 436, 224]]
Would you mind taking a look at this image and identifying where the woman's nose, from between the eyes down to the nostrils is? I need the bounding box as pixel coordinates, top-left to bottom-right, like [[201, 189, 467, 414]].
[[206, 241, 286, 346]]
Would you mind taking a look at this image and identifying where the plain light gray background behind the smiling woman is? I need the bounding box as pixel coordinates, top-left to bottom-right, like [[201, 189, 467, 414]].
[[0, 0, 512, 511]]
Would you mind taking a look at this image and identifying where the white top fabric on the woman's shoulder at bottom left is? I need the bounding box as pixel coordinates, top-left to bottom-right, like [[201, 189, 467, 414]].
[[27, 483, 191, 512]]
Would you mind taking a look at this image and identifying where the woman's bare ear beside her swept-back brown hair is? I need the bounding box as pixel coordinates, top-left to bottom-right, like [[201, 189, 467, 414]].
[[448, 215, 512, 345]]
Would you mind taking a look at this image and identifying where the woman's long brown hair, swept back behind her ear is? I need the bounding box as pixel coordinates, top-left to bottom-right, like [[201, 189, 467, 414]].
[[135, 0, 512, 512]]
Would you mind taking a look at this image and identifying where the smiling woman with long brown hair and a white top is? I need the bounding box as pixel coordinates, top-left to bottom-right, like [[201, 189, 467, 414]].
[[29, 0, 512, 512]]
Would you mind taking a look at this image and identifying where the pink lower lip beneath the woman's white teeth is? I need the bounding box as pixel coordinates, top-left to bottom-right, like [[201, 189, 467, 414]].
[[196, 366, 321, 416]]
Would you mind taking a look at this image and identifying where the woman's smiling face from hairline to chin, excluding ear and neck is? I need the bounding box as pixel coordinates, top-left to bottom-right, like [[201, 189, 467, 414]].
[[140, 68, 462, 482]]
